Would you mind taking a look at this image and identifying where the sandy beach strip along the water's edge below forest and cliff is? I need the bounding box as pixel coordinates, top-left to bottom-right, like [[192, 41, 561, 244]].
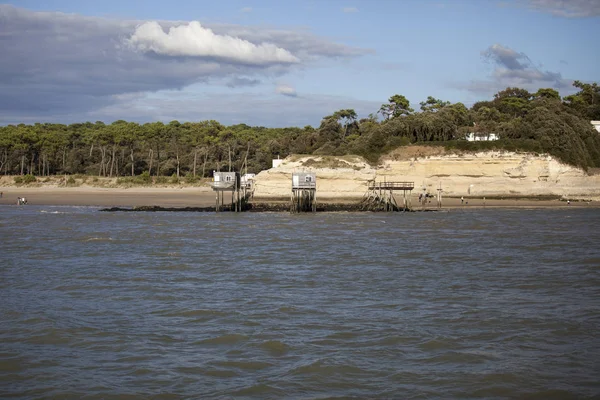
[[0, 186, 600, 212]]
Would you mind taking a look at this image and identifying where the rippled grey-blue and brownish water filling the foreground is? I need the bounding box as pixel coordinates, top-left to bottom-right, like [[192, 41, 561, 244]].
[[0, 206, 600, 399]]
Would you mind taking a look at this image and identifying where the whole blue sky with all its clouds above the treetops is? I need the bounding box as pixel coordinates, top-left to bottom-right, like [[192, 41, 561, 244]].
[[0, 0, 600, 127]]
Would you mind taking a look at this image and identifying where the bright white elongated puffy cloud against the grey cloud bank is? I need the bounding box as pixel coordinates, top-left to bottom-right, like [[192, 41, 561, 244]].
[[127, 21, 300, 64]]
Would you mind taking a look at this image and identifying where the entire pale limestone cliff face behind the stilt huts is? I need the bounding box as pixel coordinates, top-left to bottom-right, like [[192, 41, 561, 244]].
[[255, 150, 600, 199]]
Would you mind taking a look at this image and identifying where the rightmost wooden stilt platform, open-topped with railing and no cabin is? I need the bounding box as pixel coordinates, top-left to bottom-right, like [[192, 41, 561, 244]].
[[362, 180, 415, 211]]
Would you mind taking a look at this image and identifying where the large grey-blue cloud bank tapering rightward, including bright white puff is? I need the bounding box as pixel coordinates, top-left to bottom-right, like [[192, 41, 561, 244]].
[[0, 4, 372, 124]]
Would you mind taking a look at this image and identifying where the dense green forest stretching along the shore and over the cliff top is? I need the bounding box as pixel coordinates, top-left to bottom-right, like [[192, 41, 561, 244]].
[[0, 81, 600, 181]]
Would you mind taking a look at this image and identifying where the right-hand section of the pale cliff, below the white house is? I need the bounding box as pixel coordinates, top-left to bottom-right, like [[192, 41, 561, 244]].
[[378, 152, 600, 197]]
